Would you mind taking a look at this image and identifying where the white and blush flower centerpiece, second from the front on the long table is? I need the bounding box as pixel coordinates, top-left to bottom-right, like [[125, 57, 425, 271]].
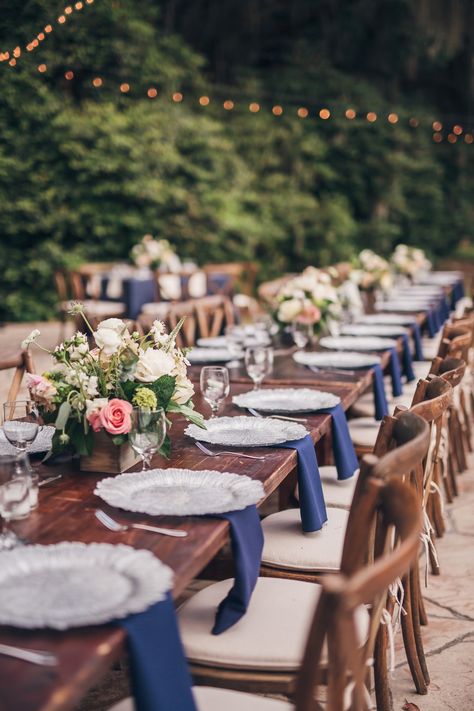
[[275, 267, 342, 336]]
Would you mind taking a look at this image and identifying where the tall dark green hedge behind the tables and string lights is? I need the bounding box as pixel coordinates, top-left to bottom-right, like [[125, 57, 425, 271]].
[[0, 0, 474, 320]]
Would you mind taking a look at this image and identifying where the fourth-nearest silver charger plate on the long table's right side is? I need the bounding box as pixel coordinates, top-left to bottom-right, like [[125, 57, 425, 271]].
[[232, 388, 341, 412]]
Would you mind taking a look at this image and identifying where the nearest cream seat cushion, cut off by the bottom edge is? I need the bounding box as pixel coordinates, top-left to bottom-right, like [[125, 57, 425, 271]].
[[109, 686, 295, 711]]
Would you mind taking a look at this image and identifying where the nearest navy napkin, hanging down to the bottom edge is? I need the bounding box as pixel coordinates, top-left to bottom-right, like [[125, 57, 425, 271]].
[[122, 593, 196, 711]]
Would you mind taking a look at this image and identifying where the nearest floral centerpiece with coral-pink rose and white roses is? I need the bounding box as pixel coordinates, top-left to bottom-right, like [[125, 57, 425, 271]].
[[22, 303, 204, 456]]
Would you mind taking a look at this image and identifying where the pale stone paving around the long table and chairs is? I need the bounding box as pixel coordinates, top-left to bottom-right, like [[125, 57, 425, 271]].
[[0, 323, 474, 711]]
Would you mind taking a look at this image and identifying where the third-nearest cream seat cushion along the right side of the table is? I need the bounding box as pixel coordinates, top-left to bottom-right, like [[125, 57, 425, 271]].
[[262, 508, 349, 572]]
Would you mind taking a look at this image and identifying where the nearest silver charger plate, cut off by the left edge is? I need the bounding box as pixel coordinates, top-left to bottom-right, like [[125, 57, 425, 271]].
[[0, 542, 173, 630]]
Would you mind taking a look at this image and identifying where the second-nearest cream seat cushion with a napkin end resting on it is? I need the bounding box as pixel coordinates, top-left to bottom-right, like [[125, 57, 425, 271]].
[[178, 578, 369, 672]]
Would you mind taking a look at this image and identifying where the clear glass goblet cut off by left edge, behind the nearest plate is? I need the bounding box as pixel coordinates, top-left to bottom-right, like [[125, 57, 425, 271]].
[[0, 456, 30, 550]]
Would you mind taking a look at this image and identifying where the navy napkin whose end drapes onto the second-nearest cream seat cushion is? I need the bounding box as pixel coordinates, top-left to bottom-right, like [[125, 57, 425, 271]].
[[212, 506, 264, 634]]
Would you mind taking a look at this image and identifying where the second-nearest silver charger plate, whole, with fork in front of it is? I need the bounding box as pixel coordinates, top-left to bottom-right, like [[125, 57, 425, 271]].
[[94, 469, 264, 516]]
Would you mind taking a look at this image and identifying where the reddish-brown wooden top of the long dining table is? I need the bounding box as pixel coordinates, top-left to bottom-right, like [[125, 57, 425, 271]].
[[0, 330, 420, 711]]
